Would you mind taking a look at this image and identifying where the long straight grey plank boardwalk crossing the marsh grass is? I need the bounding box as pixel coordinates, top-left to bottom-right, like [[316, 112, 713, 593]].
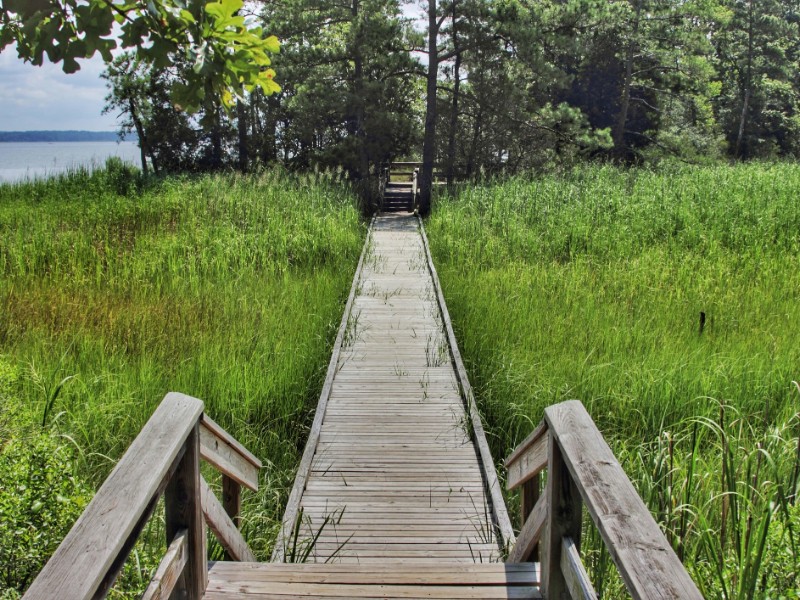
[[273, 213, 505, 564]]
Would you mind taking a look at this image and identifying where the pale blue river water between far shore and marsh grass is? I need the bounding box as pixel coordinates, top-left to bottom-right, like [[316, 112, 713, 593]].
[[0, 142, 139, 182]]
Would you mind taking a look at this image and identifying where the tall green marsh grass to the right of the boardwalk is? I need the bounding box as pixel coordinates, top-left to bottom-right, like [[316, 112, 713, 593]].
[[428, 165, 800, 599]]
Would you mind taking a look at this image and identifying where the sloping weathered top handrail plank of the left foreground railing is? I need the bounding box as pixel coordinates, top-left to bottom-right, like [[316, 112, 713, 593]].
[[25, 393, 203, 599]]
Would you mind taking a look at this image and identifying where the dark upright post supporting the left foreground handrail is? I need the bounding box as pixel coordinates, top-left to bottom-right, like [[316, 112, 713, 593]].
[[164, 422, 208, 600]]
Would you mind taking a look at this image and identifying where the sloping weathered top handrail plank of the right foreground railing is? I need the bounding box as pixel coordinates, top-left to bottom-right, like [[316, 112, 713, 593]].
[[543, 400, 702, 600]]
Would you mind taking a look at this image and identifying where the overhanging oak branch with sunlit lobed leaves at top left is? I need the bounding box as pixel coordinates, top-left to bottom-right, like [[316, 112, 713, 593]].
[[0, 0, 280, 112]]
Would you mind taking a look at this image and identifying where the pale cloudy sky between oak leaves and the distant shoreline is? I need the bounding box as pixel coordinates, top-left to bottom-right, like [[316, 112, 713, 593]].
[[0, 51, 116, 131]]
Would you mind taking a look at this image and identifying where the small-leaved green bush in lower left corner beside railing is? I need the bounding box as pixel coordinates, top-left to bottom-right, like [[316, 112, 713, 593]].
[[0, 434, 91, 597]]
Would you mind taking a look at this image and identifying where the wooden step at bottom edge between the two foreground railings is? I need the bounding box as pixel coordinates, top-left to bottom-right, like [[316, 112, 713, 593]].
[[205, 560, 542, 600]]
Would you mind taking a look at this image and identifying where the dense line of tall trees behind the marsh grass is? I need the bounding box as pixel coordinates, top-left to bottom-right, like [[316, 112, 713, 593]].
[[107, 0, 800, 198]]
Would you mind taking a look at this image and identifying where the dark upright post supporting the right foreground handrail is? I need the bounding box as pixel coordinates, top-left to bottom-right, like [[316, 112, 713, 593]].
[[540, 435, 583, 600]]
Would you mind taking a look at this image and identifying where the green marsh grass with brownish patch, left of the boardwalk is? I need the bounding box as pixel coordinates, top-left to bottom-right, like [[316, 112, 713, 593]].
[[0, 166, 365, 589]]
